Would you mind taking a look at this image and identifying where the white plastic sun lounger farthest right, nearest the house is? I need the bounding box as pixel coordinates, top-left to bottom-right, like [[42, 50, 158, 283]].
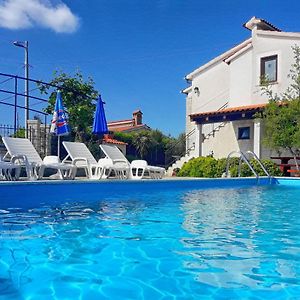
[[100, 145, 165, 179]]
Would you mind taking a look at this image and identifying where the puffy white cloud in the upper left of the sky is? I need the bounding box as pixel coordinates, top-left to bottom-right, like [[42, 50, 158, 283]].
[[0, 0, 79, 33]]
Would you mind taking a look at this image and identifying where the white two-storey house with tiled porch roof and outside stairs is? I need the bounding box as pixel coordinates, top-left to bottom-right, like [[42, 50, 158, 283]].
[[179, 17, 300, 161]]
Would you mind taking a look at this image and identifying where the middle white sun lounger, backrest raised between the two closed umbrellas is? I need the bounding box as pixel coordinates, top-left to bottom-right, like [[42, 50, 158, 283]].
[[63, 142, 118, 179]]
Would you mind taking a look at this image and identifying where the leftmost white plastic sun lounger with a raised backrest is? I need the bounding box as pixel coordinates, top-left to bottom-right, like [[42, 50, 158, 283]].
[[2, 137, 76, 180]]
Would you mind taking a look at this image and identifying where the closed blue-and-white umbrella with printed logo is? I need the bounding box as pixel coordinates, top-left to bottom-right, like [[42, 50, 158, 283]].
[[50, 91, 70, 136]]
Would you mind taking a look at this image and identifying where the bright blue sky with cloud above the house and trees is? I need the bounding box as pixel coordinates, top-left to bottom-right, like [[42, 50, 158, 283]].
[[0, 0, 300, 136]]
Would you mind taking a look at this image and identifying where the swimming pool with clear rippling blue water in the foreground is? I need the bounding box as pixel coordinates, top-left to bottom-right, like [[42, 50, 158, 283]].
[[0, 179, 300, 299]]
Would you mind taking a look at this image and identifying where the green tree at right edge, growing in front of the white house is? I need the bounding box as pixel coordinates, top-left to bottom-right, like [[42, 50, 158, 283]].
[[261, 45, 300, 170]]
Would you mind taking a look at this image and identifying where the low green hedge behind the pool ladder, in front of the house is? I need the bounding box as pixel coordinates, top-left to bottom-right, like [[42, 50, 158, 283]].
[[177, 157, 282, 178]]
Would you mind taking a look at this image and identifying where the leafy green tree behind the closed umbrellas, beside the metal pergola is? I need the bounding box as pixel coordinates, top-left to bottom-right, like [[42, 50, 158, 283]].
[[39, 71, 98, 142]]
